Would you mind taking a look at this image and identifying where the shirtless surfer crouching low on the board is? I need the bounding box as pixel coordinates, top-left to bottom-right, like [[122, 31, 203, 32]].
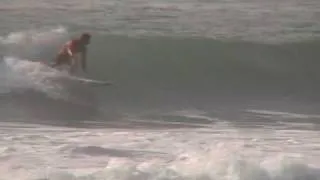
[[51, 33, 91, 73]]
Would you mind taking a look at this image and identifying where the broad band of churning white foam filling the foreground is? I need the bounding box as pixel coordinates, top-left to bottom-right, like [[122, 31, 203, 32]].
[[0, 128, 320, 180]]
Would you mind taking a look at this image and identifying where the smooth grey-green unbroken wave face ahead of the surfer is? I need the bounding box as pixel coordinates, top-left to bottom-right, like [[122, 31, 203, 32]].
[[90, 37, 320, 95]]
